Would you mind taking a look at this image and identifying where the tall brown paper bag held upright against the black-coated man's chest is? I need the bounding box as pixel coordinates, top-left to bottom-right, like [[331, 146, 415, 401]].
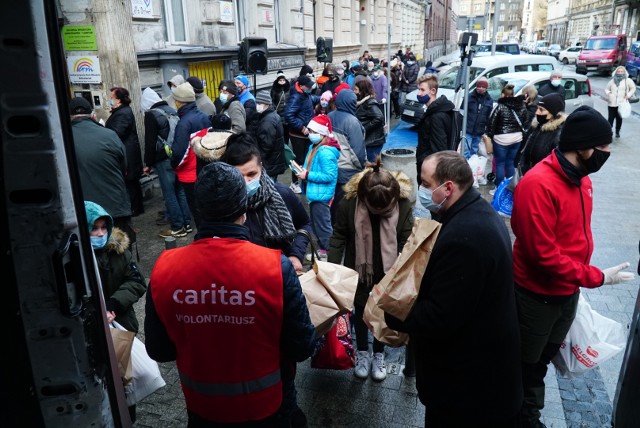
[[374, 219, 441, 321]]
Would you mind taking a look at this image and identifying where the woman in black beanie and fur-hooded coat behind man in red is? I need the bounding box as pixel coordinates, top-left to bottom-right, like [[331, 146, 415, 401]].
[[517, 93, 567, 174]]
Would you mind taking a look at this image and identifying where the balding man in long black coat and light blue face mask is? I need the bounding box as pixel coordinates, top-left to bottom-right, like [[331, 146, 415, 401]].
[[385, 151, 523, 428]]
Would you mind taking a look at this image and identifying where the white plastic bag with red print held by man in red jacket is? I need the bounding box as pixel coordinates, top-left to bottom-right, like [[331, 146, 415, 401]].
[[552, 294, 627, 377]]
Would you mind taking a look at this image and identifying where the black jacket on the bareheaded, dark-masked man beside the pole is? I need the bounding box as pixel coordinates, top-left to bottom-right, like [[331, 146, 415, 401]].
[[416, 95, 455, 173]]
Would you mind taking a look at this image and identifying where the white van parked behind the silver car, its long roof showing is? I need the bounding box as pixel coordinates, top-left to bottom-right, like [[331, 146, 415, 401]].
[[402, 54, 561, 123]]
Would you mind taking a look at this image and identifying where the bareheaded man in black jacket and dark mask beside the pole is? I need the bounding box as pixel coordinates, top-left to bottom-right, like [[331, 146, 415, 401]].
[[416, 74, 455, 180]]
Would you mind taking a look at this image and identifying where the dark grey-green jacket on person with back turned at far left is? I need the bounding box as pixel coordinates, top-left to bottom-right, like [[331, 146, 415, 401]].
[[71, 117, 131, 218]]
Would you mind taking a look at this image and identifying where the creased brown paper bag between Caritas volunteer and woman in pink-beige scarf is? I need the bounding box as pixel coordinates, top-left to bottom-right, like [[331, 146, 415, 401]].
[[299, 261, 358, 337]]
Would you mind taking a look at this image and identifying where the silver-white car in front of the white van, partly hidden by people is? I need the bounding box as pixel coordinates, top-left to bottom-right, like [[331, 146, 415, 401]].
[[487, 71, 593, 114]]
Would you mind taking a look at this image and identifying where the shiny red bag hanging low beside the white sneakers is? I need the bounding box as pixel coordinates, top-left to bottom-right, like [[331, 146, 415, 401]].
[[311, 313, 356, 370]]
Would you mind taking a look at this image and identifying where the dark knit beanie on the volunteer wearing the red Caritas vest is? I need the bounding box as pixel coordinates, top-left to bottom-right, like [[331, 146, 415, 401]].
[[194, 161, 247, 223]]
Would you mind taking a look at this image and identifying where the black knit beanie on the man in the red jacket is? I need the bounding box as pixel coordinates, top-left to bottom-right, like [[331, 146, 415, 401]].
[[556, 106, 613, 153]]
